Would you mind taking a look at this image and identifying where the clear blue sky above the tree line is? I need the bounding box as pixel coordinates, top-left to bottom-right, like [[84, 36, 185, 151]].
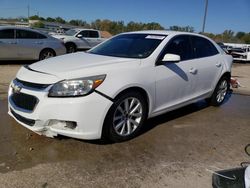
[[0, 0, 250, 33]]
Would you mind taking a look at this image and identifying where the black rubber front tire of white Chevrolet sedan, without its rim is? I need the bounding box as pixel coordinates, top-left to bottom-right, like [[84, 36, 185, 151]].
[[102, 92, 147, 142]]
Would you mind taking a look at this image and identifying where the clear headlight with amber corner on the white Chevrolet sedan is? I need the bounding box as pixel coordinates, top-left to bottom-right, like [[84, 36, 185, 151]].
[[49, 75, 106, 97]]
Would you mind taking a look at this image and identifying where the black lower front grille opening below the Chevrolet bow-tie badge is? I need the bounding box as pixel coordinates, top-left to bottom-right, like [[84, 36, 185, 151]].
[[10, 93, 38, 111]]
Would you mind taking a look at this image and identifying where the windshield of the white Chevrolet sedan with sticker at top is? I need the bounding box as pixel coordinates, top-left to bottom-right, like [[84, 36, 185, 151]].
[[89, 34, 166, 58]]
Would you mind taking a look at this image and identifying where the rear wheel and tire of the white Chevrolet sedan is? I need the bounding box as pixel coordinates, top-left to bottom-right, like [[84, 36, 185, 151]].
[[207, 76, 230, 106]]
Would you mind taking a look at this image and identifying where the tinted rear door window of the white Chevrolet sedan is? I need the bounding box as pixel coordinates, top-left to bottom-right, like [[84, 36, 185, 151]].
[[192, 36, 218, 58]]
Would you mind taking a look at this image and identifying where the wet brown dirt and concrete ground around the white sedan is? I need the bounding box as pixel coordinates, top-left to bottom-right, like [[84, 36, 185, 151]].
[[0, 64, 250, 188]]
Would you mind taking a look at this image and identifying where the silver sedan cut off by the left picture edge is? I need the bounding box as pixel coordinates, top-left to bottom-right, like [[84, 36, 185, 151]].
[[0, 26, 66, 60]]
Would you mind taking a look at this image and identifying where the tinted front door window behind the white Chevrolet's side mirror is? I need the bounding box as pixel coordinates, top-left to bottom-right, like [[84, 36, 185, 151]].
[[160, 35, 192, 61]]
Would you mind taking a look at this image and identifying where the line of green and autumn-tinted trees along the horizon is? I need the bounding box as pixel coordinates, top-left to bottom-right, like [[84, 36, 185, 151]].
[[1, 15, 250, 44]]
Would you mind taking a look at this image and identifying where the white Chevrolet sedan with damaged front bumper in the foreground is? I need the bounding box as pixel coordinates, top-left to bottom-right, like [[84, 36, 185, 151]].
[[8, 31, 232, 142]]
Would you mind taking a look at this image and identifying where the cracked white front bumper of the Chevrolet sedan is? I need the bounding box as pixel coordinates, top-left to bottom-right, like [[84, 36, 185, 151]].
[[8, 81, 113, 140]]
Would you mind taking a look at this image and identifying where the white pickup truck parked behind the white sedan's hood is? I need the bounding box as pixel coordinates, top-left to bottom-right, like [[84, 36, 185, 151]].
[[52, 28, 106, 53]]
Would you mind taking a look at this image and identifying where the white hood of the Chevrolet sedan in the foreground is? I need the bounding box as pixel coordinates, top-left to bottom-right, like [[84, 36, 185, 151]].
[[29, 52, 140, 79]]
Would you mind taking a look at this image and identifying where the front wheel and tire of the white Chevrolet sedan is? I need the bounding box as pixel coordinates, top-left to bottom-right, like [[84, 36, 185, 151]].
[[102, 92, 147, 142]]
